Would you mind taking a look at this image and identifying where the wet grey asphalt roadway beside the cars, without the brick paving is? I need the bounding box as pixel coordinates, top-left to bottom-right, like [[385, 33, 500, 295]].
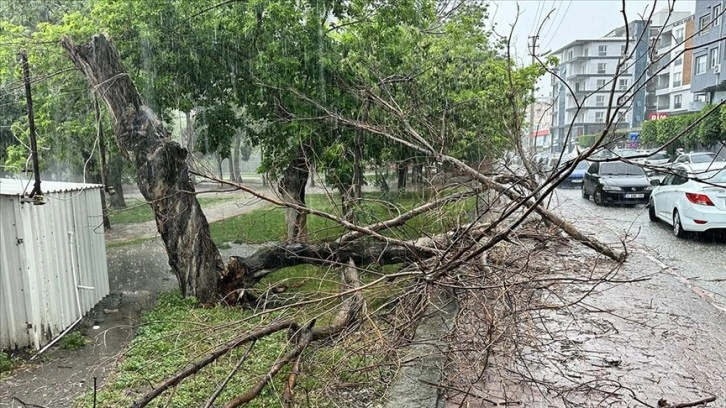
[[551, 189, 726, 310]]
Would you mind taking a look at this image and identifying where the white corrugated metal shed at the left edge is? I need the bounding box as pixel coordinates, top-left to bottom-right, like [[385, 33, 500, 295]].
[[0, 179, 109, 349]]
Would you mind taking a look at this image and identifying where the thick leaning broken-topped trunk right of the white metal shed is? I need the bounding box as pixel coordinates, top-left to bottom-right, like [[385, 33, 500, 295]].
[[61, 35, 224, 302]]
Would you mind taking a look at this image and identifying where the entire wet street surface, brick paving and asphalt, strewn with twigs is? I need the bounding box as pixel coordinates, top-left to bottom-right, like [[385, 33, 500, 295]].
[[447, 186, 726, 408]]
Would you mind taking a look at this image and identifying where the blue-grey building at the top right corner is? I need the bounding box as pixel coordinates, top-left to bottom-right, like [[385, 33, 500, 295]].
[[691, 0, 726, 105]]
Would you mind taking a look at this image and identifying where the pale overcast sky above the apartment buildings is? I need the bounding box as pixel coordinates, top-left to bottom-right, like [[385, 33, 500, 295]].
[[489, 0, 696, 63]]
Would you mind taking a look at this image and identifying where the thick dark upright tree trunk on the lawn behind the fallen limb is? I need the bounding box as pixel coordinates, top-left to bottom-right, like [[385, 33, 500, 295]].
[[278, 151, 309, 242]]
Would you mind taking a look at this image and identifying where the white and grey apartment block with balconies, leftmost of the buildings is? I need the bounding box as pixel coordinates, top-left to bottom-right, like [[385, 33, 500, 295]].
[[550, 10, 691, 152]]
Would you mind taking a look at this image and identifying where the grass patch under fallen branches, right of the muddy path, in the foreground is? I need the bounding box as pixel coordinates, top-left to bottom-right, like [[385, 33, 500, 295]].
[[74, 293, 286, 407]]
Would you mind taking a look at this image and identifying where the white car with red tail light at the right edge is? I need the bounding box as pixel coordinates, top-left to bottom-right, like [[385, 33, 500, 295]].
[[648, 162, 726, 238]]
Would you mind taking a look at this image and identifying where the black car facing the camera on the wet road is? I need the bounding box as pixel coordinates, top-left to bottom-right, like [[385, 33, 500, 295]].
[[582, 161, 653, 205]]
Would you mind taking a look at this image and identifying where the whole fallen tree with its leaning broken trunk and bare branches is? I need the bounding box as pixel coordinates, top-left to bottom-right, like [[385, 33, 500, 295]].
[[63, 32, 623, 407]]
